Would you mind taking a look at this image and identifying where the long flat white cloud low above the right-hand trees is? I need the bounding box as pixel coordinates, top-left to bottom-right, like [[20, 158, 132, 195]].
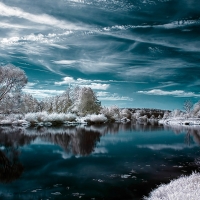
[[138, 89, 200, 97]]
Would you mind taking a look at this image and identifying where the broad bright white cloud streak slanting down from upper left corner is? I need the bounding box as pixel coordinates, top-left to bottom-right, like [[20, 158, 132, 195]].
[[0, 2, 82, 30]]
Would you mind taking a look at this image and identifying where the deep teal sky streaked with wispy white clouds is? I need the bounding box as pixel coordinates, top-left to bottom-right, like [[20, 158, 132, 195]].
[[0, 0, 200, 110]]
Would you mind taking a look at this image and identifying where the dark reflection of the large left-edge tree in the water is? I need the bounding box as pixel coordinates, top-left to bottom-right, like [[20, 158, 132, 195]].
[[0, 127, 35, 183]]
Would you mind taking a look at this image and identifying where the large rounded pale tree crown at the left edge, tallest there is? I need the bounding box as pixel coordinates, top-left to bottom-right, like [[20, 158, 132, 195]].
[[0, 64, 27, 102]]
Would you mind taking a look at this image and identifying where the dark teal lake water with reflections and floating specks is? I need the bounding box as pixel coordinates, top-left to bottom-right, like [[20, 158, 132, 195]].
[[0, 123, 200, 200]]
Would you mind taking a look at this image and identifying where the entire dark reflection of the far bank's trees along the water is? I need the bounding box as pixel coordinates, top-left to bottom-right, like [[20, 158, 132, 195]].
[[0, 123, 200, 182]]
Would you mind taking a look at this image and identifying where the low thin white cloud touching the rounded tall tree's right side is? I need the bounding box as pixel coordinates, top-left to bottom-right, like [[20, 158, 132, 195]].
[[97, 91, 133, 101]]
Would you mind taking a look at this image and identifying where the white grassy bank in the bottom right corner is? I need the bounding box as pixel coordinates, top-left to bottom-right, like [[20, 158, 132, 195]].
[[144, 173, 200, 200]]
